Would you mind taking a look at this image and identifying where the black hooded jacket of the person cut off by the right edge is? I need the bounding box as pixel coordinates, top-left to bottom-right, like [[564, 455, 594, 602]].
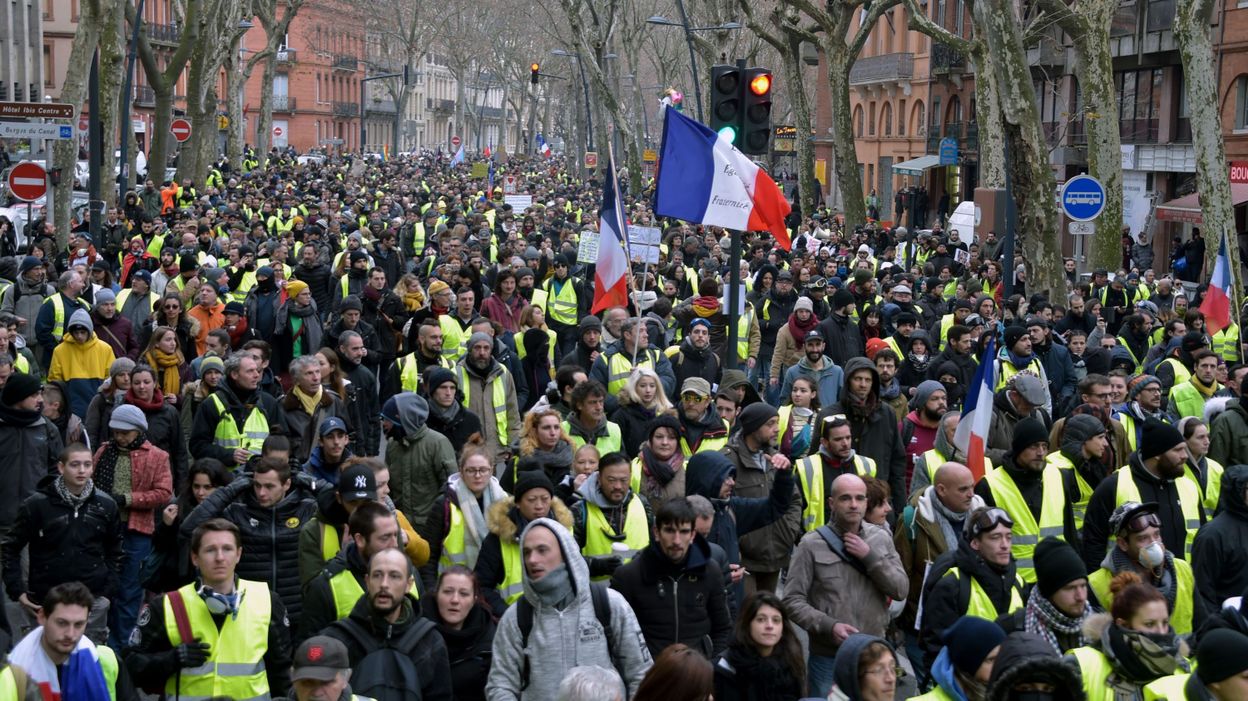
[[1188, 465, 1248, 612]]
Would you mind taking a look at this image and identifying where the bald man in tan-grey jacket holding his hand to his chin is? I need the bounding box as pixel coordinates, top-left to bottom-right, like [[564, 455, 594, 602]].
[[784, 474, 910, 699]]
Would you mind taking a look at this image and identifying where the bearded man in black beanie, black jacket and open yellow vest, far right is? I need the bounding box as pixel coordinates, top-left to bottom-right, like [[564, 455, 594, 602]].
[[1083, 414, 1206, 571]]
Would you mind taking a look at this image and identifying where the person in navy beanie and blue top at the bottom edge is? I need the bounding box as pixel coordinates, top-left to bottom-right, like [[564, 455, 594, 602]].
[[912, 616, 1006, 701]]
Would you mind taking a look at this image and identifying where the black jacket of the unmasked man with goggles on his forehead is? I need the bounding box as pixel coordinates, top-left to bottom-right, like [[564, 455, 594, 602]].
[[919, 538, 1017, 665]]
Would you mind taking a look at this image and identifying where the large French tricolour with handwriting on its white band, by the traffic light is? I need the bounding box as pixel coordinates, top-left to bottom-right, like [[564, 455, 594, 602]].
[[654, 110, 791, 251]]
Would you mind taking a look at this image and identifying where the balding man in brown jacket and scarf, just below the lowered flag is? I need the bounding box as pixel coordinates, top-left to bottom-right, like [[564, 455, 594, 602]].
[[892, 461, 983, 681]]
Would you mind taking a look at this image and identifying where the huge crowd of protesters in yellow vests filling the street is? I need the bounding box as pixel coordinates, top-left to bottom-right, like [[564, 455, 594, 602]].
[[0, 144, 1248, 701]]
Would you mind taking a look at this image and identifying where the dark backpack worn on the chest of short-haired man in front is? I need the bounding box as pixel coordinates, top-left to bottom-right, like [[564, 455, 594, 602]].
[[333, 617, 436, 701]]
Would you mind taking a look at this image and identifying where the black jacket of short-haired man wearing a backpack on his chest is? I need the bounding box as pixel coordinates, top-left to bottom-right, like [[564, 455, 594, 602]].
[[322, 594, 456, 701]]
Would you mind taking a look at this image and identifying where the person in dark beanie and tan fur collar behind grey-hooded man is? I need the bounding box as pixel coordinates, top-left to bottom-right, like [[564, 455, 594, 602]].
[[474, 470, 579, 617]]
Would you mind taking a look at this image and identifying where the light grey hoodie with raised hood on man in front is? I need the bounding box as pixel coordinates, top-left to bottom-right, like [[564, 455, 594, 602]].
[[485, 519, 653, 701]]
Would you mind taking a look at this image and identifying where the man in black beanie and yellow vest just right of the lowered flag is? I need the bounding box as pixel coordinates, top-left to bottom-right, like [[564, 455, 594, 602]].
[[975, 417, 1080, 584]]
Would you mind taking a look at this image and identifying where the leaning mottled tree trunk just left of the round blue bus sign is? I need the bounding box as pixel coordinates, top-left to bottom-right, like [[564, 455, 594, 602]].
[[975, 0, 1066, 294]]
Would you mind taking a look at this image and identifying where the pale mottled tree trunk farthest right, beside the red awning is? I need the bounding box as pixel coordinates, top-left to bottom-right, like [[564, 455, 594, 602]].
[[1174, 0, 1243, 284]]
